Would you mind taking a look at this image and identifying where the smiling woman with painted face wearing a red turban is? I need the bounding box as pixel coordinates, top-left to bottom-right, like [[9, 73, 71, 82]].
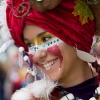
[[0, 0, 100, 100]]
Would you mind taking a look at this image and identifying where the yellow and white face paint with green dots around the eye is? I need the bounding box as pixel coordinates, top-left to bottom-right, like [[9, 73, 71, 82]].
[[29, 32, 62, 54]]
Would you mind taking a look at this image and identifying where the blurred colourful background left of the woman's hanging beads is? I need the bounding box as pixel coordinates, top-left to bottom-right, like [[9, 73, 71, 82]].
[[0, 38, 33, 100]]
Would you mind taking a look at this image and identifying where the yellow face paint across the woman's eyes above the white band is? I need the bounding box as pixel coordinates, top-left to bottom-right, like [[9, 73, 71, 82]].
[[25, 32, 55, 46]]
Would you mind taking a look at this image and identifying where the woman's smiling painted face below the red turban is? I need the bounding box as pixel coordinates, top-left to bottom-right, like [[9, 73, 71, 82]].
[[23, 25, 78, 81]]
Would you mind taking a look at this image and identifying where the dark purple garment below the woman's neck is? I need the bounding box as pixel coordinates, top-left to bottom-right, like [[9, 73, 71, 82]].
[[52, 77, 98, 100]]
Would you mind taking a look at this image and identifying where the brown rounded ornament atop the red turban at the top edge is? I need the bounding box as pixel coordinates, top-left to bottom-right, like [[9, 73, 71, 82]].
[[30, 0, 61, 12]]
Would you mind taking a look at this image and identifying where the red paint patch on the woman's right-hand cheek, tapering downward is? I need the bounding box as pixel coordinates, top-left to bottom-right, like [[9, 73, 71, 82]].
[[47, 45, 63, 68]]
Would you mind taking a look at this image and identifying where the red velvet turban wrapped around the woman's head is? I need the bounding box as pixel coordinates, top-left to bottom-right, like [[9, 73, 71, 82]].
[[6, 0, 95, 52]]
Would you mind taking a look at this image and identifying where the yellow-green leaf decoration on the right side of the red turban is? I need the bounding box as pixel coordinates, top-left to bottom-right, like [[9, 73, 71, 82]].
[[72, 0, 94, 25]]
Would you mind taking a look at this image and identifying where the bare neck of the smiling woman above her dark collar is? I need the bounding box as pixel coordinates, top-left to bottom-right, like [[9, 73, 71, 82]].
[[58, 60, 97, 88]]
